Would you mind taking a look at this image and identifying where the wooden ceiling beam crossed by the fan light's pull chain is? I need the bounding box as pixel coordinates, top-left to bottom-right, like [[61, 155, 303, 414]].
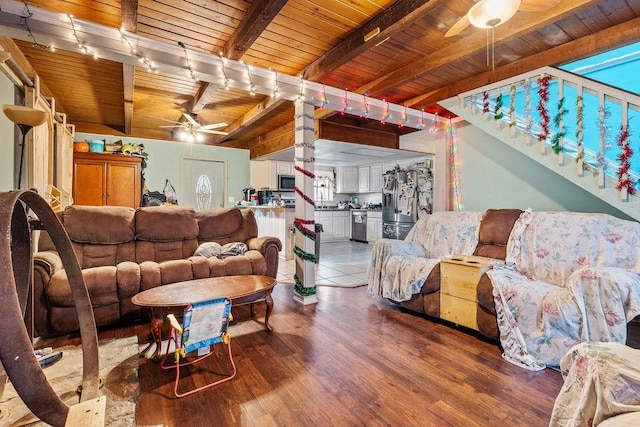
[[355, 0, 598, 96]]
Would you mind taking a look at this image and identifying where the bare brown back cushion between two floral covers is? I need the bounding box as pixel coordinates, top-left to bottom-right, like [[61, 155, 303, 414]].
[[473, 209, 522, 259]]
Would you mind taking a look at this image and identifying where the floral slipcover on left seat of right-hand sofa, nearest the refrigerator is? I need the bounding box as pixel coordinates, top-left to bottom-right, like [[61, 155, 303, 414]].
[[367, 211, 484, 302]]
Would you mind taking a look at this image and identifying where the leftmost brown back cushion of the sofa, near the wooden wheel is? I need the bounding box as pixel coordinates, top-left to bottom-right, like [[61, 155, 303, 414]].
[[63, 205, 135, 246]]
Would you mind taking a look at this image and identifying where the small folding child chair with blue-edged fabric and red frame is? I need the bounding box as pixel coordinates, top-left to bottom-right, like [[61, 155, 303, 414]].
[[160, 298, 236, 397]]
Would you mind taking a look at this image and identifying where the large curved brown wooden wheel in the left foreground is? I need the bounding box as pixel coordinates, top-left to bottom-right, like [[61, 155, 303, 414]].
[[0, 190, 99, 426]]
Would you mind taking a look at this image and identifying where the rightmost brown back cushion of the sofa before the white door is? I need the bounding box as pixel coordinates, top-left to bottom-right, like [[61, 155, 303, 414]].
[[196, 208, 258, 245]]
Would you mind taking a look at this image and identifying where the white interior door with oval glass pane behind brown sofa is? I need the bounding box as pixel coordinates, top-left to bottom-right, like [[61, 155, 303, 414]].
[[179, 158, 227, 211]]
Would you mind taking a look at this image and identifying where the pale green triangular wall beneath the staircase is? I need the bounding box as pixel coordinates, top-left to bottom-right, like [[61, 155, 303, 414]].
[[457, 125, 631, 219]]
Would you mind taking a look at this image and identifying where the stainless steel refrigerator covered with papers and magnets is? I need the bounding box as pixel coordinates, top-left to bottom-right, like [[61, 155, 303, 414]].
[[382, 165, 433, 239]]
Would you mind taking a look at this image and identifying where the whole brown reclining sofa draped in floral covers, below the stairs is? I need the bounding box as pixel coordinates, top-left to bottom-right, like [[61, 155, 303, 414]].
[[367, 210, 640, 370]]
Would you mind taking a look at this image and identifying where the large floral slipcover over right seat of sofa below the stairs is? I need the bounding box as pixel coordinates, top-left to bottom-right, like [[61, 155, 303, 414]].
[[488, 211, 640, 370]]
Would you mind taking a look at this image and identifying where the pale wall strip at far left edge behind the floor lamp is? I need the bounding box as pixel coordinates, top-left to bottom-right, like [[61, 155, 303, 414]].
[[0, 73, 16, 191]]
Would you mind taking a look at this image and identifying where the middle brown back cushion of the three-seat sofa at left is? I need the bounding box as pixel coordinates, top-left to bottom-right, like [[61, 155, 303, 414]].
[[136, 206, 198, 244]]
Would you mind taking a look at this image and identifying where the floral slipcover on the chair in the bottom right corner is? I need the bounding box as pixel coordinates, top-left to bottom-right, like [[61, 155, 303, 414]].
[[549, 342, 640, 427]]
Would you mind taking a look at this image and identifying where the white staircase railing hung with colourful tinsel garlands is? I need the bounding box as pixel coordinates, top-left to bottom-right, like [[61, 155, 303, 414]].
[[448, 67, 640, 209]]
